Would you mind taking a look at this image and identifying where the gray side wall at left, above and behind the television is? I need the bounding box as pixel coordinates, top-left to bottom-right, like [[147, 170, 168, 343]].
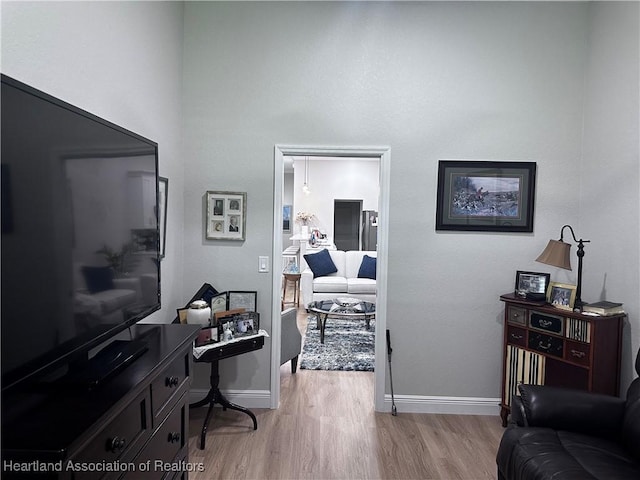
[[1, 2, 184, 323]]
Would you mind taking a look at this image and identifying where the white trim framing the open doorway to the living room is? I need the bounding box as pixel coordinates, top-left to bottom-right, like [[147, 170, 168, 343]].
[[270, 145, 391, 412]]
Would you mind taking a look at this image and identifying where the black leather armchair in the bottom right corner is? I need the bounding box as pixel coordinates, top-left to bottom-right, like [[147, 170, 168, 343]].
[[496, 351, 640, 480]]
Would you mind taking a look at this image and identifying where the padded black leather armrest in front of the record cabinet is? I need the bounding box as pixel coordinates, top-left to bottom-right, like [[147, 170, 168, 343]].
[[512, 384, 625, 437]]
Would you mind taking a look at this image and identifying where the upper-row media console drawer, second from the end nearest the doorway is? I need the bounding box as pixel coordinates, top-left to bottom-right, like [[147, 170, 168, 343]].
[[71, 389, 151, 479]]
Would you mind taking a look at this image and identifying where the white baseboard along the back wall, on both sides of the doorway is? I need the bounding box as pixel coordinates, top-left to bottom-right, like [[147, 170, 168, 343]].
[[189, 389, 500, 416]]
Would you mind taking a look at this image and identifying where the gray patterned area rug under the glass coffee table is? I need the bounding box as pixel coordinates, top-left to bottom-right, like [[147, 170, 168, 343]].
[[300, 315, 376, 372]]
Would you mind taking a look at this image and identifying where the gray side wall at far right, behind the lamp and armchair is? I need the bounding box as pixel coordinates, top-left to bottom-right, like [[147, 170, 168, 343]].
[[576, 2, 640, 386]]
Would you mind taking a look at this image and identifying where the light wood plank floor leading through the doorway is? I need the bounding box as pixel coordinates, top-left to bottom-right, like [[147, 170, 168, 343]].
[[189, 298, 503, 480]]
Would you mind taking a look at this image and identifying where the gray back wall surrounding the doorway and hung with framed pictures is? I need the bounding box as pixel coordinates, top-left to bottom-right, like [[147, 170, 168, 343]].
[[184, 2, 638, 398]]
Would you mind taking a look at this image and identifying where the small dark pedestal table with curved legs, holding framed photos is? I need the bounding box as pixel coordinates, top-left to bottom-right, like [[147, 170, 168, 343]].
[[189, 335, 264, 450]]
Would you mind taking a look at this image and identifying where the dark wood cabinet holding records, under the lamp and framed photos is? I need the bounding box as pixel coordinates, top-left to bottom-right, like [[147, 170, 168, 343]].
[[500, 293, 626, 427]]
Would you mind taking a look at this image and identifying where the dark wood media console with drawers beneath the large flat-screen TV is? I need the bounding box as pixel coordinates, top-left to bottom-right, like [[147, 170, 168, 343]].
[[0, 324, 199, 480]]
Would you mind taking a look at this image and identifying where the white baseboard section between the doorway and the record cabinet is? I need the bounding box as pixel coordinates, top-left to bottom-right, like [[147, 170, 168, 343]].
[[384, 394, 500, 416]]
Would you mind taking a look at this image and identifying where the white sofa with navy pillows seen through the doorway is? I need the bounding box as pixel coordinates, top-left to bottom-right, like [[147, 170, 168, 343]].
[[300, 250, 377, 307]]
